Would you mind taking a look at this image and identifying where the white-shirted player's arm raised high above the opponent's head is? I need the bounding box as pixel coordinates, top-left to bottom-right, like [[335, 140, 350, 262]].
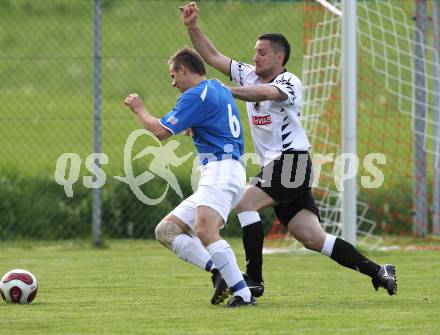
[[180, 2, 231, 76]]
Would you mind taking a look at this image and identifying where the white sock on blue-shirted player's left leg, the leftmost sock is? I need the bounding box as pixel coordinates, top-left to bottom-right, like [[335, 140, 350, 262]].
[[171, 234, 212, 271]]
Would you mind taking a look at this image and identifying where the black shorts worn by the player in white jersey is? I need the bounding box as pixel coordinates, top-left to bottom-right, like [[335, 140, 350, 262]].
[[254, 151, 320, 226]]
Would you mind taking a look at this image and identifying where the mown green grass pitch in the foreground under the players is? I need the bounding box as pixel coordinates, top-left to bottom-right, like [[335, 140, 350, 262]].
[[0, 240, 440, 335]]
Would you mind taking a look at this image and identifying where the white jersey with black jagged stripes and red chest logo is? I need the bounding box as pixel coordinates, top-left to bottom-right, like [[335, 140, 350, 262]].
[[231, 60, 310, 166]]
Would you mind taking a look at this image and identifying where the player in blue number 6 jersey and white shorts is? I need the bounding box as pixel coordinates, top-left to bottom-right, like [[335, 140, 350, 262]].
[[125, 48, 256, 307]]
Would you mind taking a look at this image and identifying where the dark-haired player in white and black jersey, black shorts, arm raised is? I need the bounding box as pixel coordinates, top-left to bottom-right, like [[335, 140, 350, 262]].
[[181, 2, 397, 297]]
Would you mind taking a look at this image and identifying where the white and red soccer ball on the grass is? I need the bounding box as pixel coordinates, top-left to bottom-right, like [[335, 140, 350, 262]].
[[0, 269, 38, 304]]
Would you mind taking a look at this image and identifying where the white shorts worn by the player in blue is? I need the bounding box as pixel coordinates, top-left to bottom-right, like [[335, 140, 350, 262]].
[[171, 159, 246, 231]]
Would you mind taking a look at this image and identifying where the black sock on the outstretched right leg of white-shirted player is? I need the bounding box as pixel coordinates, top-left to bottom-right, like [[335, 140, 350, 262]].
[[331, 237, 380, 278]]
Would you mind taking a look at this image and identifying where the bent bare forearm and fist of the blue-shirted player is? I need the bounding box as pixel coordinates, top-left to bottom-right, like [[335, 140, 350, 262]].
[[124, 93, 172, 141]]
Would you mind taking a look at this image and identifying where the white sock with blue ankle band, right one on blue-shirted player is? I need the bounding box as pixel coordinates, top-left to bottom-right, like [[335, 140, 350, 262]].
[[206, 240, 251, 301]]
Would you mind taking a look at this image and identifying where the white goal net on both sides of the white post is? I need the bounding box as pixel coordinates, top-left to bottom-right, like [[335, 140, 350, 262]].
[[267, 0, 440, 252]]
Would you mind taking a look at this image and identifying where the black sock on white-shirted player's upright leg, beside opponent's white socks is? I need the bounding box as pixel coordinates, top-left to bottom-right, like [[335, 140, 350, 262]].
[[243, 221, 264, 282]]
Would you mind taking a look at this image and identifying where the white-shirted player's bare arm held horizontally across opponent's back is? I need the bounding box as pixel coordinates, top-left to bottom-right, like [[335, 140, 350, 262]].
[[229, 84, 287, 102]]
